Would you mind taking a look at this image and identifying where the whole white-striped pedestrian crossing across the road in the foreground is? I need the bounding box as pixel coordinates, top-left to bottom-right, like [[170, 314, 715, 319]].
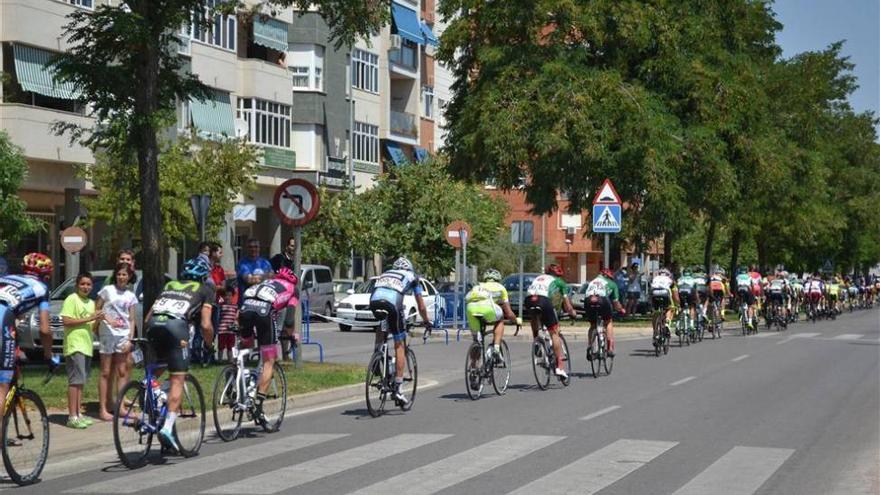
[[59, 433, 794, 495]]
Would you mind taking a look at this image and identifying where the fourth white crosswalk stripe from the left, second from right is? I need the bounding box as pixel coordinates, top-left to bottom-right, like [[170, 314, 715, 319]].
[[509, 439, 678, 495]]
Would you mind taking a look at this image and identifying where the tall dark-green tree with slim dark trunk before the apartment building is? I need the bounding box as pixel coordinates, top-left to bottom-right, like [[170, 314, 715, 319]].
[[49, 0, 390, 306]]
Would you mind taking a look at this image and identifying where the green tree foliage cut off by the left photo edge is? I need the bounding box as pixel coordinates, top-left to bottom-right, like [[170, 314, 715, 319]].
[[0, 130, 42, 253]]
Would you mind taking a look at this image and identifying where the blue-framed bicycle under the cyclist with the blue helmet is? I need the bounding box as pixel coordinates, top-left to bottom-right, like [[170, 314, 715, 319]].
[[113, 338, 205, 469]]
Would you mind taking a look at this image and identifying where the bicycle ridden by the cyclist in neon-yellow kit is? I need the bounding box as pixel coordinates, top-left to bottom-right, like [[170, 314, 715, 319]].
[[464, 314, 511, 400]]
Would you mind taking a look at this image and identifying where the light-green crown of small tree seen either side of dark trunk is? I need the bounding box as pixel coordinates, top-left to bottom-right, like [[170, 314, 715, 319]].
[[79, 136, 259, 245]]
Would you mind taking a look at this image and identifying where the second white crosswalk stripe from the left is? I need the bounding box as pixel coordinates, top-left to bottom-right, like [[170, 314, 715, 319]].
[[202, 434, 452, 494]]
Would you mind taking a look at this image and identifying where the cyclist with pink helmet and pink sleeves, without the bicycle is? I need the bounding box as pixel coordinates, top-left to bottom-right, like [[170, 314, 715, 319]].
[[238, 267, 299, 424]]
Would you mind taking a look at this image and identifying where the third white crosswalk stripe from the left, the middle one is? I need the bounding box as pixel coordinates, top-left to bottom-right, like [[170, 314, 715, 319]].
[[351, 435, 565, 495]]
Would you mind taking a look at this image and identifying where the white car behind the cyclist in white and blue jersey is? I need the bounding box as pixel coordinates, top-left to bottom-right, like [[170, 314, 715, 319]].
[[336, 277, 446, 332]]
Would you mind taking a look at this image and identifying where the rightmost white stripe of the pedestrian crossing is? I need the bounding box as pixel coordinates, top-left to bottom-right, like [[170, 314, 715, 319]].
[[673, 447, 794, 495]]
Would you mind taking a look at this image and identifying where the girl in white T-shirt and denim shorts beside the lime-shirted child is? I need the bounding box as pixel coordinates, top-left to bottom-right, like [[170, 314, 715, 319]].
[[95, 263, 138, 421]]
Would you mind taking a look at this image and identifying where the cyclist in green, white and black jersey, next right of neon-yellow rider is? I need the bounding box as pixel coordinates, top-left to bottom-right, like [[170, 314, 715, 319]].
[[527, 263, 577, 379]]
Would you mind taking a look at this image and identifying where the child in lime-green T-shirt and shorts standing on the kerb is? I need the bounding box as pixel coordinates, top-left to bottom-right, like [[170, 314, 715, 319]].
[[61, 273, 104, 429]]
